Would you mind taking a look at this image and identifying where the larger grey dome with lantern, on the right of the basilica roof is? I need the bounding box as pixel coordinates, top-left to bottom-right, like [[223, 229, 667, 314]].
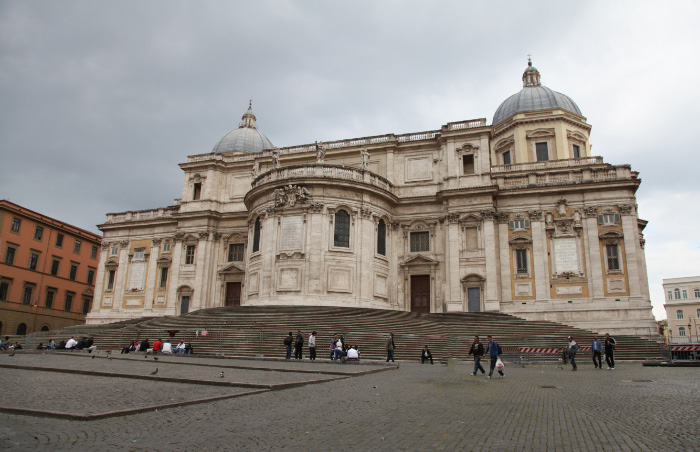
[[492, 61, 583, 126]]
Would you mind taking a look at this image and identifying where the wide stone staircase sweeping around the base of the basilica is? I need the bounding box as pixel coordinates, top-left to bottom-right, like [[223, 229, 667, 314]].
[[27, 306, 660, 361]]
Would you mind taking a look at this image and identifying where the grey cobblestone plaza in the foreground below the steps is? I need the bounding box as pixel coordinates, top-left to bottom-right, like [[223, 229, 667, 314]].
[[0, 352, 700, 451]]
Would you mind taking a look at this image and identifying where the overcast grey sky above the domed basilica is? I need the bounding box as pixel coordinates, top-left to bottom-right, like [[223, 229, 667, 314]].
[[0, 0, 700, 318]]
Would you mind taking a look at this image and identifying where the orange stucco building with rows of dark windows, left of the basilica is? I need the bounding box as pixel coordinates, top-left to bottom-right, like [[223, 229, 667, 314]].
[[0, 200, 102, 336]]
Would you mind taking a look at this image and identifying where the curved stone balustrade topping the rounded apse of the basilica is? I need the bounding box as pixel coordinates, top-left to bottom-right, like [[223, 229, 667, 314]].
[[252, 163, 393, 190]]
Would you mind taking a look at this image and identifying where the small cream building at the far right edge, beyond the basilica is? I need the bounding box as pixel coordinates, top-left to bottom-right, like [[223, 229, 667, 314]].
[[663, 276, 700, 343]]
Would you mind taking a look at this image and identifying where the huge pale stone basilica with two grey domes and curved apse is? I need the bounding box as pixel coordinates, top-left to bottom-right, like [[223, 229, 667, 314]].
[[88, 62, 656, 335]]
